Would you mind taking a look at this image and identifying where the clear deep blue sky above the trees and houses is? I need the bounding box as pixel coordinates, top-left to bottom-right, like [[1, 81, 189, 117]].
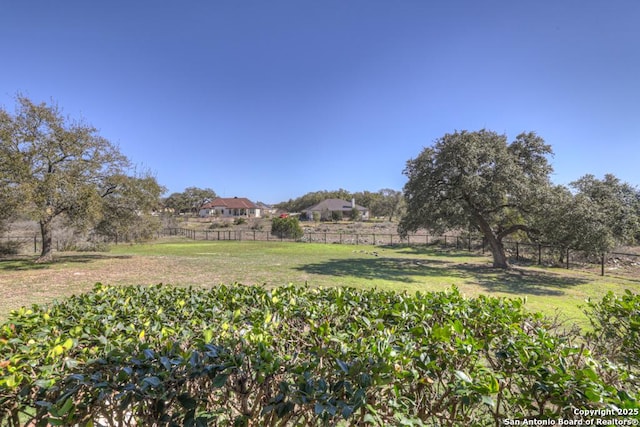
[[0, 0, 640, 203]]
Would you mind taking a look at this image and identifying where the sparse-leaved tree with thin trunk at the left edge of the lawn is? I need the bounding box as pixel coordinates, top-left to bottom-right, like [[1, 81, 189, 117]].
[[0, 96, 129, 261]]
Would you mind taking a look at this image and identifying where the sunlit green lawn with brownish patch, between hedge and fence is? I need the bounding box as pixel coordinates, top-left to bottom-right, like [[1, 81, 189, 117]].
[[0, 240, 640, 327]]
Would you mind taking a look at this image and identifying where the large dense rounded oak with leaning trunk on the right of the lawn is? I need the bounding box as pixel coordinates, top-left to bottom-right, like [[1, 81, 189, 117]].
[[399, 130, 552, 268]]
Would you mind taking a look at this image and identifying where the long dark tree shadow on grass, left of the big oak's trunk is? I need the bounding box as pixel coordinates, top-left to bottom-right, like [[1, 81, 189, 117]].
[[296, 257, 462, 283]]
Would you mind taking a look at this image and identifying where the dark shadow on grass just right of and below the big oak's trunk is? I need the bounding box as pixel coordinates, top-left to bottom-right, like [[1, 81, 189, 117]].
[[455, 264, 589, 296]]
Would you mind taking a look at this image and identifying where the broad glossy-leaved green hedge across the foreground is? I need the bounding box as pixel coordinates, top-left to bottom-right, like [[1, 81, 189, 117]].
[[0, 284, 639, 426]]
